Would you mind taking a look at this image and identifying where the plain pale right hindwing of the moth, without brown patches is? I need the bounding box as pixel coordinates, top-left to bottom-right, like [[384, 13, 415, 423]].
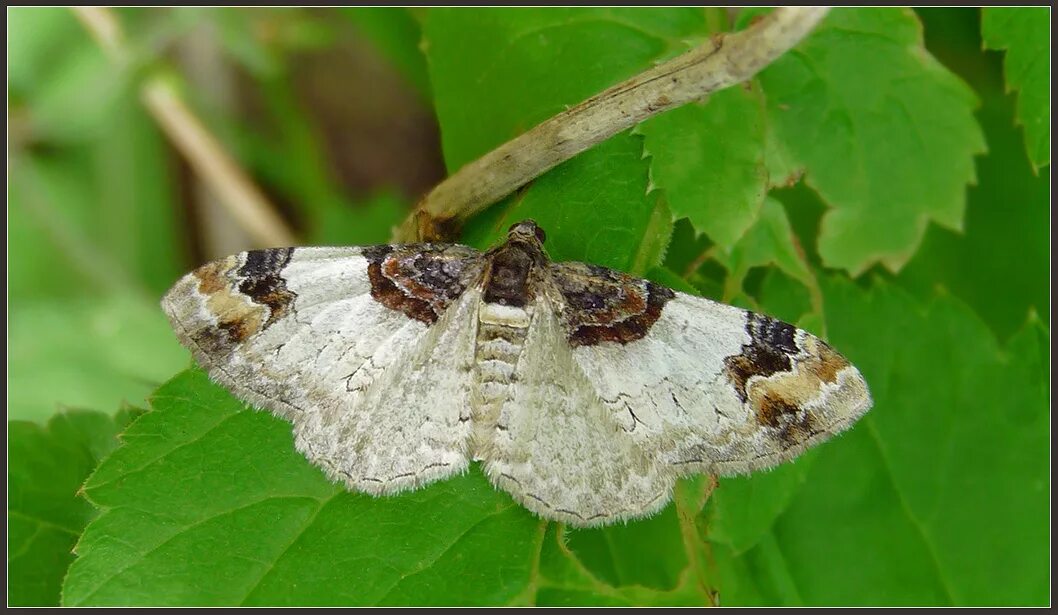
[[478, 303, 675, 526]]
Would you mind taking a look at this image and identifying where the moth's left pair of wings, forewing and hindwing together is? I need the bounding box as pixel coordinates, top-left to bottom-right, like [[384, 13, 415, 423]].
[[162, 245, 481, 494]]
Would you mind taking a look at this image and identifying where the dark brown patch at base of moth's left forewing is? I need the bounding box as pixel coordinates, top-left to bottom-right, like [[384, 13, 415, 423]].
[[364, 243, 482, 325]]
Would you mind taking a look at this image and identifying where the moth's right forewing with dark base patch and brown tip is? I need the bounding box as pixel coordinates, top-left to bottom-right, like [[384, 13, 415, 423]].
[[551, 264, 872, 475]]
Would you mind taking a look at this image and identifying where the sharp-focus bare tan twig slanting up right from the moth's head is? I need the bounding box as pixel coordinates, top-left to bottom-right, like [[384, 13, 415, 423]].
[[396, 7, 827, 241]]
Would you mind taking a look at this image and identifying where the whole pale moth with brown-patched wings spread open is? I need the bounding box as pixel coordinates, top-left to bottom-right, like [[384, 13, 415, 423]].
[[162, 220, 872, 526]]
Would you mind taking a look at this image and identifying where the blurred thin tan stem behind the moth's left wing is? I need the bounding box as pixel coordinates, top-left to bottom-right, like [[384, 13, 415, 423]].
[[73, 6, 297, 247]]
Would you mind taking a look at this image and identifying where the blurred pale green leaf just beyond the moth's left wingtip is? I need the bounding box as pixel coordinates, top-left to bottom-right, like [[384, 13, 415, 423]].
[[7, 294, 188, 420]]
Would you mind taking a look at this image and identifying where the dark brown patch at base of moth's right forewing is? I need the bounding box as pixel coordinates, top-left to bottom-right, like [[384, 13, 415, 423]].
[[550, 263, 675, 346]]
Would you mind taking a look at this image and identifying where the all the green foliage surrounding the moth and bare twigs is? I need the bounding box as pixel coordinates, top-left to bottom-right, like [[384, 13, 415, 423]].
[[8, 8, 1051, 605]]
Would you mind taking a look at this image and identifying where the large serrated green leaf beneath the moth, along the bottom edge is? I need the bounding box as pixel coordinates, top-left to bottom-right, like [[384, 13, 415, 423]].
[[63, 369, 719, 605]]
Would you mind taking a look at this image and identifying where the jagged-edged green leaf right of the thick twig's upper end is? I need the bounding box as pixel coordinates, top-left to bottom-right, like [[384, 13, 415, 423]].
[[759, 8, 985, 275]]
